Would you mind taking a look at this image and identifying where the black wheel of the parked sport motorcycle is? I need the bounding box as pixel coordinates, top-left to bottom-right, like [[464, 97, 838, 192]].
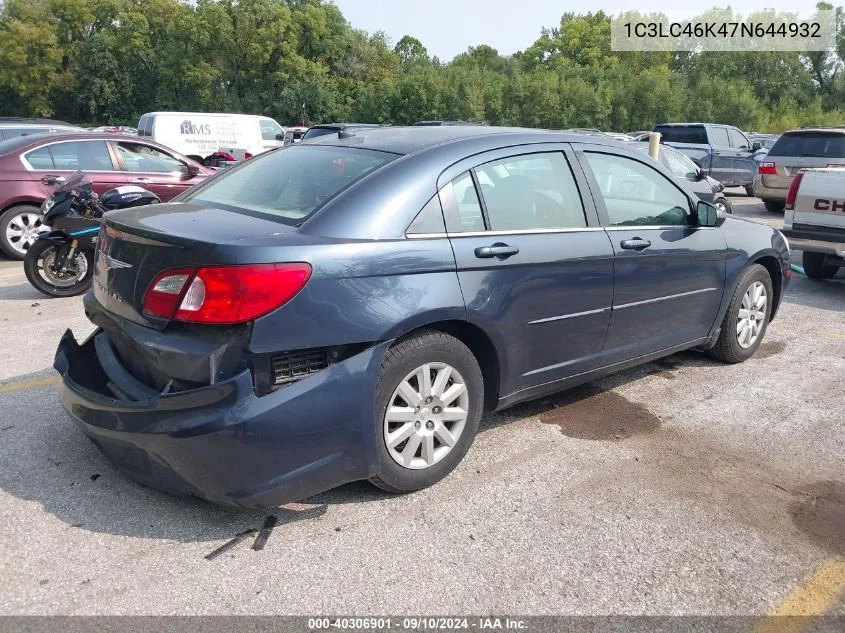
[[23, 240, 94, 297]]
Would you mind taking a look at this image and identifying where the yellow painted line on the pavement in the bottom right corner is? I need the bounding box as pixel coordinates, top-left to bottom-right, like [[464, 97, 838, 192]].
[[754, 558, 845, 633]]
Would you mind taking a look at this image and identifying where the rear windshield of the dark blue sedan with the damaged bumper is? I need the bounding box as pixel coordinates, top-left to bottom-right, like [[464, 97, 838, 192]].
[[180, 145, 399, 225]]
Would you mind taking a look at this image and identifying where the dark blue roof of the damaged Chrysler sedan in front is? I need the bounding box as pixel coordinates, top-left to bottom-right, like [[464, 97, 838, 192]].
[[302, 125, 627, 155]]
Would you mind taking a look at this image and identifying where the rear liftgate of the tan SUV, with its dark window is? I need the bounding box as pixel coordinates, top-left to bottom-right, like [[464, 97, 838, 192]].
[[760, 130, 845, 198]]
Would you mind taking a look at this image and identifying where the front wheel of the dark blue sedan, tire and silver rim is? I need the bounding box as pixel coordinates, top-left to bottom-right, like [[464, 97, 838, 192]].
[[709, 264, 774, 363]]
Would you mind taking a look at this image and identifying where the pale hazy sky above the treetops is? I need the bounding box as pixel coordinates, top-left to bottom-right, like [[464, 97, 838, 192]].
[[333, 0, 820, 61]]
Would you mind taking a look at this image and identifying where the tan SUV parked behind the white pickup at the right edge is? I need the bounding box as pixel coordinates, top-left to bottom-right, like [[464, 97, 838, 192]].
[[754, 128, 845, 213]]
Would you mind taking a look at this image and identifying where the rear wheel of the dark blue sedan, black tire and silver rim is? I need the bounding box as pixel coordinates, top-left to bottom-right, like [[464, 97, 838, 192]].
[[370, 330, 484, 493]]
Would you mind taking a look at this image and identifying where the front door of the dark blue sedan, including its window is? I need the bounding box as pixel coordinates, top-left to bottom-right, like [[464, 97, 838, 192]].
[[578, 146, 727, 365]]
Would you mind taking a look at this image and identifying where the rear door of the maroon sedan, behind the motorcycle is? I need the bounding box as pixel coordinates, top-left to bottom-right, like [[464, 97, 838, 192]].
[[23, 139, 126, 197]]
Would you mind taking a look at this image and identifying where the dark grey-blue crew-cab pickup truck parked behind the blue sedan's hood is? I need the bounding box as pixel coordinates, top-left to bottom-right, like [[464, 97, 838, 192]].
[[654, 123, 763, 196]]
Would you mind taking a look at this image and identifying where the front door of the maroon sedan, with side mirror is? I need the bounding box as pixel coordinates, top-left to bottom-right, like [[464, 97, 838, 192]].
[[112, 140, 202, 202]]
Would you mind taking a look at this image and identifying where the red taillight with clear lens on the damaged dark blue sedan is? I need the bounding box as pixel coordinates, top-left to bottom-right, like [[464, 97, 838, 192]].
[[143, 263, 311, 324]]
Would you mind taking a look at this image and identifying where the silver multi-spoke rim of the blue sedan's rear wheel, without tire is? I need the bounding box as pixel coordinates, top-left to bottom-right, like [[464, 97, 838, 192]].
[[384, 363, 469, 470]]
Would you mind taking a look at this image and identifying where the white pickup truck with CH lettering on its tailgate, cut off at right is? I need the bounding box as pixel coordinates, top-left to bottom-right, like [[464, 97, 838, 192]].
[[783, 168, 845, 279]]
